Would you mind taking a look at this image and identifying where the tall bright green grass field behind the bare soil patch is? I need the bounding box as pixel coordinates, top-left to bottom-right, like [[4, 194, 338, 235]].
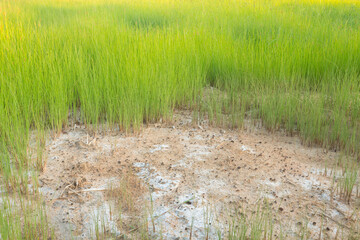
[[0, 0, 360, 239]]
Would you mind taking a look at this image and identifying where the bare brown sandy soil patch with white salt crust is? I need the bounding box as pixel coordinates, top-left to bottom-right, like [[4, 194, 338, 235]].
[[39, 113, 356, 239]]
